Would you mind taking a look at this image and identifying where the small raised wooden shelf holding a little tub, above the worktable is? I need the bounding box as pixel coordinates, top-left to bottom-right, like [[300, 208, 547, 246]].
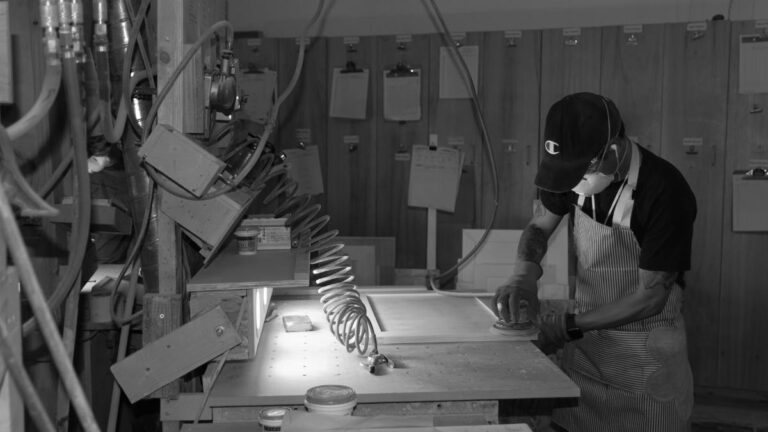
[[187, 242, 309, 292]]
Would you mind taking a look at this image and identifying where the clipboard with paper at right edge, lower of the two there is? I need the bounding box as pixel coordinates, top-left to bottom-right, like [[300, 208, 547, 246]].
[[731, 168, 768, 232]]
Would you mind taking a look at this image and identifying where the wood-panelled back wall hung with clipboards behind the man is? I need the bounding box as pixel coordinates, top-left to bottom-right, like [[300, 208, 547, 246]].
[[238, 21, 768, 391]]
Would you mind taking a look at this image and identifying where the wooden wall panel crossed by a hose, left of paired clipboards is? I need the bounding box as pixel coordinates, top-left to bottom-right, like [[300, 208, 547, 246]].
[[272, 38, 328, 214]]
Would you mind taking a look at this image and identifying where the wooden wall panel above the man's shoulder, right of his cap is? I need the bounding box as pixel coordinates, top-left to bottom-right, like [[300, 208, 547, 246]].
[[600, 24, 665, 154]]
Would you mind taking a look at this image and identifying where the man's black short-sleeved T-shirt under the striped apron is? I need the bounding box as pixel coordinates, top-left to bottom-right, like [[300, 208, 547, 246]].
[[539, 147, 696, 273]]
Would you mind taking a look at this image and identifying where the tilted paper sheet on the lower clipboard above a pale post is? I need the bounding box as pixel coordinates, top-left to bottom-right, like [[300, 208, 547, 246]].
[[408, 145, 464, 213]]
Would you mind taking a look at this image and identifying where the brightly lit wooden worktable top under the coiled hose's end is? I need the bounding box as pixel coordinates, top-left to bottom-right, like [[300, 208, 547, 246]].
[[208, 299, 579, 407]]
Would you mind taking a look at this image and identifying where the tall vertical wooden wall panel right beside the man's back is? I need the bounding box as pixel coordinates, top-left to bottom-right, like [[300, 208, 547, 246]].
[[656, 21, 730, 385]]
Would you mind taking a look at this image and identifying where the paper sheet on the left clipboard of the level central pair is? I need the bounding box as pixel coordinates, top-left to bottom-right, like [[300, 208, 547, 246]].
[[329, 68, 370, 120]]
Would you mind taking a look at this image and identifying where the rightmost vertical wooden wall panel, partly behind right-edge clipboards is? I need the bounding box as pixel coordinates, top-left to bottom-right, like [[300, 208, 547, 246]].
[[718, 22, 768, 391]]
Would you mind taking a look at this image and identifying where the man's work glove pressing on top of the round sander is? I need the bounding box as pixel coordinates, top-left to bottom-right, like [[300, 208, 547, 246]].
[[493, 261, 543, 323]]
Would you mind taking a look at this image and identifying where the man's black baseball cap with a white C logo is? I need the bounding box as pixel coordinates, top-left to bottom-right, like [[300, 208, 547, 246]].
[[535, 92, 624, 193]]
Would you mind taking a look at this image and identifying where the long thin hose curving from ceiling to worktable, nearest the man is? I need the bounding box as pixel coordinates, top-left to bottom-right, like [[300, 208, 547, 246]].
[[422, 0, 499, 297]]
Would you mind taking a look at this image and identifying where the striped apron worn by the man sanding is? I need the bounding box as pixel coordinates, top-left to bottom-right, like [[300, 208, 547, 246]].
[[553, 145, 693, 432]]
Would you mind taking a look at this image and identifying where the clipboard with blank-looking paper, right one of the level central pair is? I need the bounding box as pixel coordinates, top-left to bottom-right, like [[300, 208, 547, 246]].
[[382, 62, 421, 122]]
